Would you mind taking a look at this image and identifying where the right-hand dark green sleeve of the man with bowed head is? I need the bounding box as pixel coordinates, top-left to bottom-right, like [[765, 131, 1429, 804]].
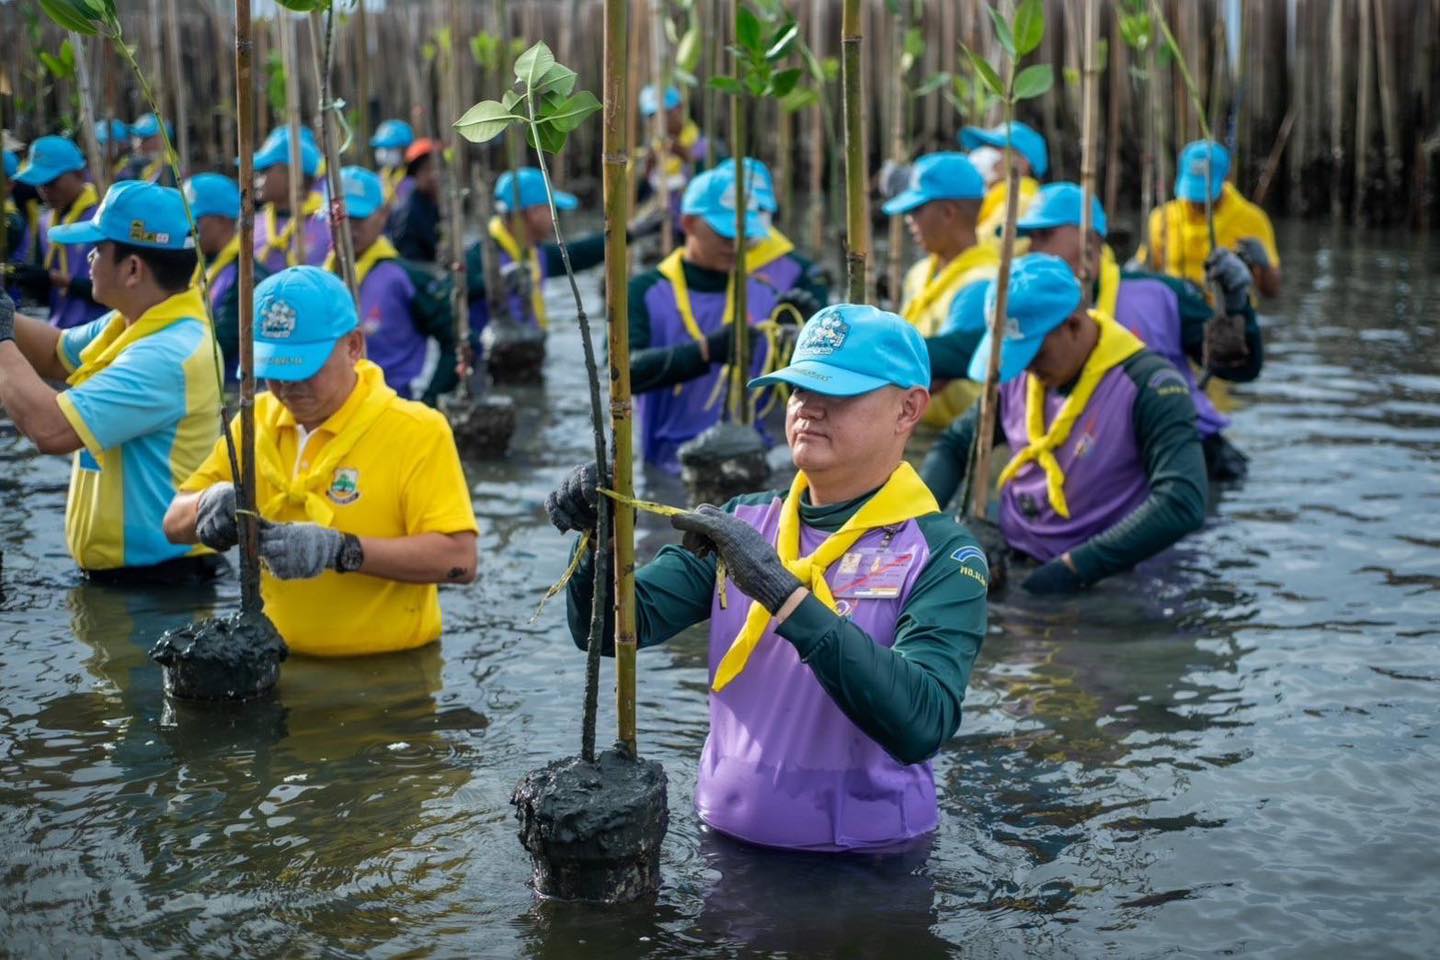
[[1070, 351, 1208, 583]]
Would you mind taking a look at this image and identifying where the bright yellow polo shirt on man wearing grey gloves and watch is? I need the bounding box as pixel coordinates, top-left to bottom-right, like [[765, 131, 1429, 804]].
[[180, 360, 478, 656]]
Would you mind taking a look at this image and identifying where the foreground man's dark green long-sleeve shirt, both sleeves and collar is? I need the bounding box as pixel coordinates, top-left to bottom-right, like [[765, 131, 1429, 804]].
[[567, 492, 989, 763]]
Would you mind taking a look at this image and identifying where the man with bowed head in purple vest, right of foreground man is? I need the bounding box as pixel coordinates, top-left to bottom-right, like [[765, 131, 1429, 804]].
[[922, 253, 1207, 593]]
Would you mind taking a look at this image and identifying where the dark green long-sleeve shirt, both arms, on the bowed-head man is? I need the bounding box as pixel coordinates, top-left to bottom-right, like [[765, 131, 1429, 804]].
[[920, 350, 1208, 583]]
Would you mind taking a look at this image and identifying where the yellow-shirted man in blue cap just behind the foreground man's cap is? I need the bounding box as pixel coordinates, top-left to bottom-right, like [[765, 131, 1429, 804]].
[[883, 153, 999, 427]]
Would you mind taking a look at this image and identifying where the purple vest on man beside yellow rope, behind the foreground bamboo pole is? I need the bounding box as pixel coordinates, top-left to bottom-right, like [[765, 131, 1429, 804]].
[[635, 256, 801, 474]]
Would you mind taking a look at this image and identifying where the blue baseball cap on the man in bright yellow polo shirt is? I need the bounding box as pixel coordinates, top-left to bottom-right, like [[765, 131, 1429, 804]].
[[255, 266, 360, 383]]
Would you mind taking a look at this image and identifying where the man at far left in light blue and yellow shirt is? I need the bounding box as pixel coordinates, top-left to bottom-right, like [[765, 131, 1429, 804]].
[[0, 180, 223, 583]]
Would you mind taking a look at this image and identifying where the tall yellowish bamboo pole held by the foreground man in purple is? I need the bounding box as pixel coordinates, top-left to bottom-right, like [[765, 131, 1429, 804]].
[[600, 0, 636, 756]]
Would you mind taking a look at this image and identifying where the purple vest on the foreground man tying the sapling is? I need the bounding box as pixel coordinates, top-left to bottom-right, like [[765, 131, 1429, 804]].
[[696, 494, 939, 851]]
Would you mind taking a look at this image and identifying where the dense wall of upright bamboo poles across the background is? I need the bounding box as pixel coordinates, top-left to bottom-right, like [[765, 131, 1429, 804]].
[[0, 0, 1440, 233]]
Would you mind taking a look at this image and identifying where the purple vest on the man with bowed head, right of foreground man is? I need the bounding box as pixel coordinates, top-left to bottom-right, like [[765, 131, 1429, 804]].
[[999, 364, 1151, 563]]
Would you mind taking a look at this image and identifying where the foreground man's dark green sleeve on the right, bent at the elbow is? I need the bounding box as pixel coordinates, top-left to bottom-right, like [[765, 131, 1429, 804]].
[[778, 515, 989, 763]]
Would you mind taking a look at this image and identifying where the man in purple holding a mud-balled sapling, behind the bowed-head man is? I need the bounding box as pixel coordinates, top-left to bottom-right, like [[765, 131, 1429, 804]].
[[1019, 183, 1264, 481]]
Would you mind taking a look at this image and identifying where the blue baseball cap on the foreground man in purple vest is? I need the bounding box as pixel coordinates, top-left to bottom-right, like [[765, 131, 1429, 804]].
[[750, 304, 930, 397]]
